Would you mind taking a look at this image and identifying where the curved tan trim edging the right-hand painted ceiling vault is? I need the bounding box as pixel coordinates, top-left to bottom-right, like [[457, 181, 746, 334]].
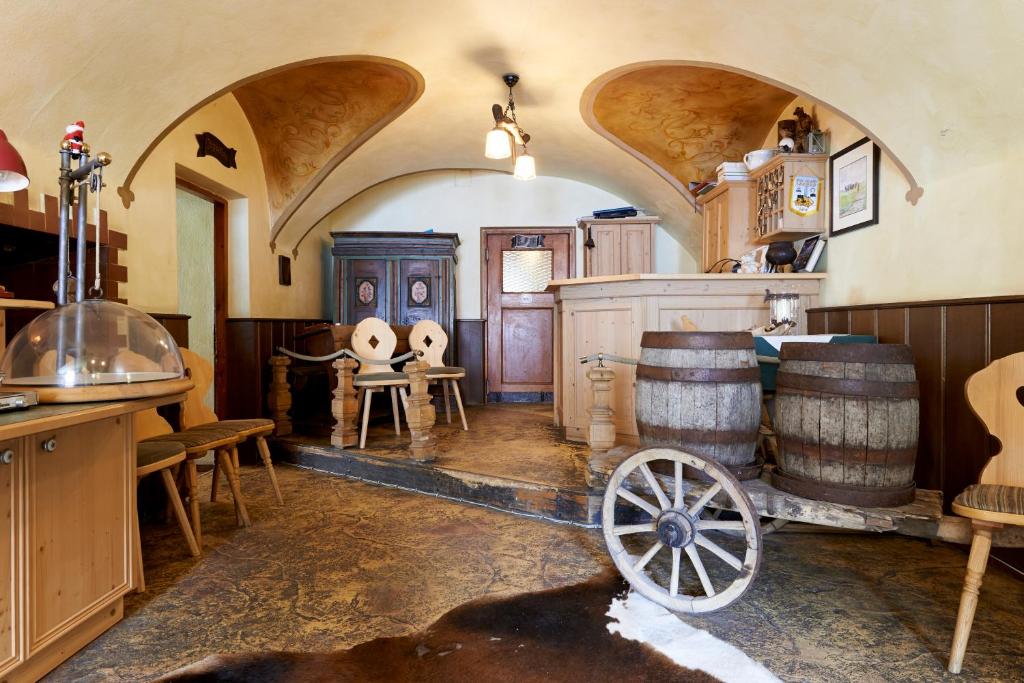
[[580, 59, 925, 206]]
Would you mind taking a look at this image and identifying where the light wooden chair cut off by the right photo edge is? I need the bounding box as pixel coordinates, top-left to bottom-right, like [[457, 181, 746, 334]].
[[949, 352, 1024, 674]]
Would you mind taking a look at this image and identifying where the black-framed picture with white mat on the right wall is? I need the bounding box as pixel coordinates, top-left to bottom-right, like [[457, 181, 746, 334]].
[[828, 137, 882, 237]]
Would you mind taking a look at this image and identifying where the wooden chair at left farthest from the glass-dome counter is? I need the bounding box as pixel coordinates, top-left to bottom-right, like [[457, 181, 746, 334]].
[[172, 348, 285, 505]]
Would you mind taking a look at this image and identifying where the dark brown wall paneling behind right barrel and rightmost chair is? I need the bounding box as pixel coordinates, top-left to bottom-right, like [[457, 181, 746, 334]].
[[807, 296, 1024, 509]]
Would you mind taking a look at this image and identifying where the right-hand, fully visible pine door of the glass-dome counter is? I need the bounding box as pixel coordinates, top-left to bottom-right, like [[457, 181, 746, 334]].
[[25, 417, 134, 654]]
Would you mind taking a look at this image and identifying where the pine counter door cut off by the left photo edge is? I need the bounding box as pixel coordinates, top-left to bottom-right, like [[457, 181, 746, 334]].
[[0, 440, 25, 674]]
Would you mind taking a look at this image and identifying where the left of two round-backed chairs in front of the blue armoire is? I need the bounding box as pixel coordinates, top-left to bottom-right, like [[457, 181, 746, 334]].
[[350, 317, 409, 449]]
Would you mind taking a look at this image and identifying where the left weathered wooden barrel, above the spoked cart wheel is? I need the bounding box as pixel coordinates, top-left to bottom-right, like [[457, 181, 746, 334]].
[[635, 332, 761, 478]]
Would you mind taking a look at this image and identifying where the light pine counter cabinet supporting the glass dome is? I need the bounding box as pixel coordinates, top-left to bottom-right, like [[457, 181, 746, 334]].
[[0, 395, 182, 681]]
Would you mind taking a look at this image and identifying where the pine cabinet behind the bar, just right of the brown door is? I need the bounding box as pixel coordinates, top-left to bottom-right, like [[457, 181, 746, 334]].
[[579, 216, 660, 278]]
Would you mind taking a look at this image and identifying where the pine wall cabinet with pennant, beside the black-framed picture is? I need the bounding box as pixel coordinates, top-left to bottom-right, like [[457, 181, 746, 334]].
[[751, 155, 828, 244]]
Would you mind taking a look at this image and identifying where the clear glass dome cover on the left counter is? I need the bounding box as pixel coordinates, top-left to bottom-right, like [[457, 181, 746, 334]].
[[0, 299, 185, 388]]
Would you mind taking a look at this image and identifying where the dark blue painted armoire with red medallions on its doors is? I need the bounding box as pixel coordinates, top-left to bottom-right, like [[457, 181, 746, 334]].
[[331, 231, 459, 362]]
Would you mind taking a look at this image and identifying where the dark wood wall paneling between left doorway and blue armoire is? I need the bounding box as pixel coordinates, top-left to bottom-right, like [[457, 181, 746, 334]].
[[224, 317, 329, 420]]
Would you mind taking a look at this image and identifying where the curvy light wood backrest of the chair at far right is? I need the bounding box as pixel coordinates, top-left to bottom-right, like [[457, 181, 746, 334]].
[[965, 352, 1024, 486]]
